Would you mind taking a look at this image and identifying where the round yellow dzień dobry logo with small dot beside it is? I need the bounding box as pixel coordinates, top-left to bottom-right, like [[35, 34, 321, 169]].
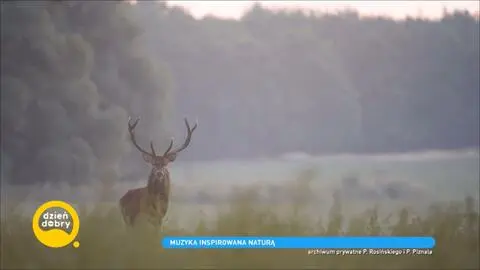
[[32, 201, 80, 248]]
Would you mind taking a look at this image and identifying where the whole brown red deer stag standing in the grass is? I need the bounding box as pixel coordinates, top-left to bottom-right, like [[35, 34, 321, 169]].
[[120, 119, 197, 227]]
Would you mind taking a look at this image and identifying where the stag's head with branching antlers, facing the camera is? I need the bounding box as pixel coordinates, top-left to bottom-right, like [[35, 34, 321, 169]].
[[128, 118, 198, 168]]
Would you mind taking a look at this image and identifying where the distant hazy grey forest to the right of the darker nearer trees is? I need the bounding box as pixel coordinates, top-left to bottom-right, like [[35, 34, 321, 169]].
[[135, 3, 480, 159]]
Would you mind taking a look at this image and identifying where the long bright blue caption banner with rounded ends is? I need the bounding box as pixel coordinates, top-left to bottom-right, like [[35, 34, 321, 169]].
[[162, 236, 435, 249]]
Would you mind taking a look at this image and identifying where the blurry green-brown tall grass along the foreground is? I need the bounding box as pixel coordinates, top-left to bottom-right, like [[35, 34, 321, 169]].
[[1, 172, 479, 269]]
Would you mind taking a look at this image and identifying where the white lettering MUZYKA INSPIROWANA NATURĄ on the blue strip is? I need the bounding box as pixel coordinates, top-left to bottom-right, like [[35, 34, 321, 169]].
[[168, 239, 275, 248]]
